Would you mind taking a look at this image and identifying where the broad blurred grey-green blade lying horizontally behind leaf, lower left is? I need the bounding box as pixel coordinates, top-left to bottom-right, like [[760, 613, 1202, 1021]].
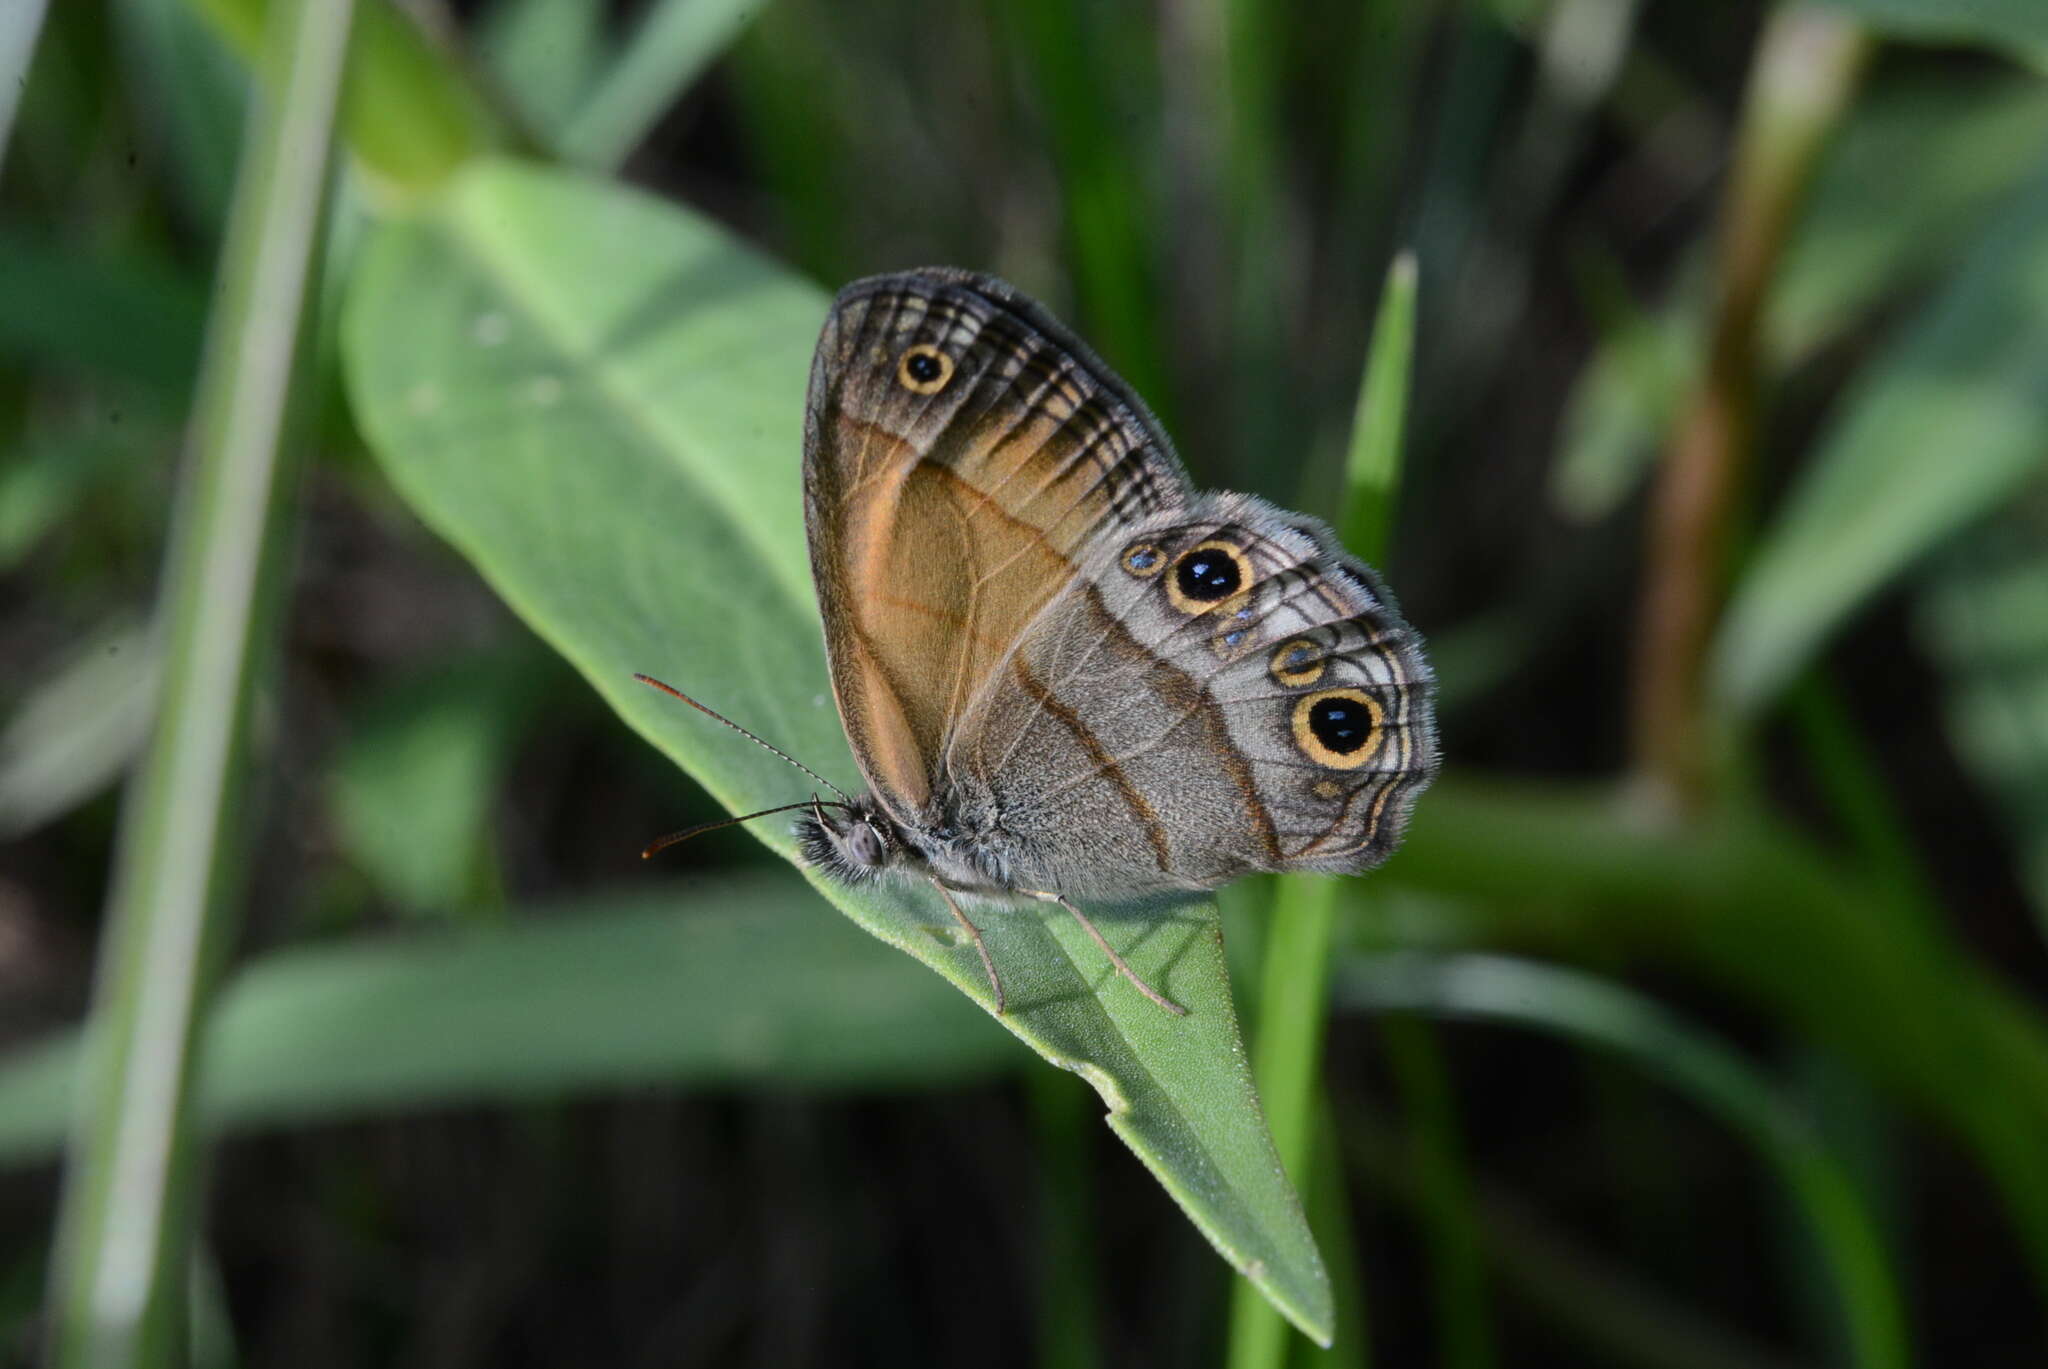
[[0, 871, 1022, 1164]]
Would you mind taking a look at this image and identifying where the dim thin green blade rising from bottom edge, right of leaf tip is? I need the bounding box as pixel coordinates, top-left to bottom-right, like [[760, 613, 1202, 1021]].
[[1380, 1014, 1499, 1369]]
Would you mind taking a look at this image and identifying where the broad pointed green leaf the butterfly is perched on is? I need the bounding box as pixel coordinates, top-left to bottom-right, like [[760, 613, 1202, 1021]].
[[342, 164, 1329, 1340]]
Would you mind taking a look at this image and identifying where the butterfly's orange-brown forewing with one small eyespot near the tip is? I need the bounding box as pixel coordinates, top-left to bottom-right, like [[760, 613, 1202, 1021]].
[[805, 271, 1192, 822]]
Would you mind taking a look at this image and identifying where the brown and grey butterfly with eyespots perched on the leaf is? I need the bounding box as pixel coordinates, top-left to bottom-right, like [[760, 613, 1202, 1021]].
[[643, 268, 1438, 1012]]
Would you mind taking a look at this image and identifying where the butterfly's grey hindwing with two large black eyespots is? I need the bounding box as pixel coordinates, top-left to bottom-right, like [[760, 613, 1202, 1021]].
[[956, 494, 1438, 896]]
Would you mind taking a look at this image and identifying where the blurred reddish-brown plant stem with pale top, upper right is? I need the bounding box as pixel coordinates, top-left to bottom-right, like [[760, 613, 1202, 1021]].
[[1632, 2, 1870, 814]]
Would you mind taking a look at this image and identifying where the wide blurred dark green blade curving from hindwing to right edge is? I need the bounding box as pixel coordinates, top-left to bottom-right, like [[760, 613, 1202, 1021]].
[[1386, 775, 2048, 1289]]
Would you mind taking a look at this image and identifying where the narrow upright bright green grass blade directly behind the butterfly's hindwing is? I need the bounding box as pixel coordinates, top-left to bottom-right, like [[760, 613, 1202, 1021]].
[[1229, 252, 1415, 1369]]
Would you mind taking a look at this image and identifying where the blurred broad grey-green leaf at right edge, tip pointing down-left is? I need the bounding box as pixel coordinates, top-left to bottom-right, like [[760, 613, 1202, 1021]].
[[1712, 168, 2048, 713]]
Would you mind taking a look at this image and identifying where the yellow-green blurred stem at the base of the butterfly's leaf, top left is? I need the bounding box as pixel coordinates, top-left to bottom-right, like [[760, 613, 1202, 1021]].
[[186, 0, 508, 199]]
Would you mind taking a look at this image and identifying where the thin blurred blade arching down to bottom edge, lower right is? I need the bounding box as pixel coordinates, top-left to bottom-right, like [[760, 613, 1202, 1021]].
[[1335, 955, 1911, 1369]]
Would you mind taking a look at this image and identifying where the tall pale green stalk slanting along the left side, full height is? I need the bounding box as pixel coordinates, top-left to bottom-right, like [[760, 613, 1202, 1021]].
[[49, 0, 354, 1369]]
